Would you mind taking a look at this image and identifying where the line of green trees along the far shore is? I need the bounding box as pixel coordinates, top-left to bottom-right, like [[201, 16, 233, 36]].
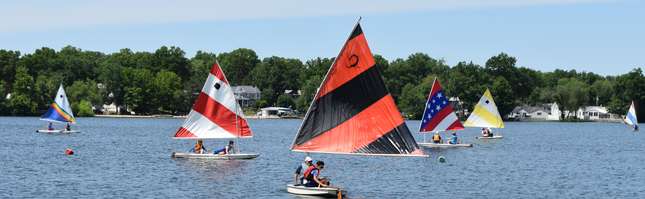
[[0, 46, 645, 121]]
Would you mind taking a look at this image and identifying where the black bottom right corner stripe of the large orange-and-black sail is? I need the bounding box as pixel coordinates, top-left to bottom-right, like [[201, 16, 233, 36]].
[[355, 123, 423, 155]]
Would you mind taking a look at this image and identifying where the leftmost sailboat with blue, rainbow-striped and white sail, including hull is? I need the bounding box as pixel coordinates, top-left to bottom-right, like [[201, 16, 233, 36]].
[[36, 84, 80, 133]]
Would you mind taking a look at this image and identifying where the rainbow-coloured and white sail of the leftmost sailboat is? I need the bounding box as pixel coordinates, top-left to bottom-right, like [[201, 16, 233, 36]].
[[40, 84, 76, 123]]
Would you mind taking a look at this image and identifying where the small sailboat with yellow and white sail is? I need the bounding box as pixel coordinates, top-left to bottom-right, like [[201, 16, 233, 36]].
[[464, 88, 504, 139]]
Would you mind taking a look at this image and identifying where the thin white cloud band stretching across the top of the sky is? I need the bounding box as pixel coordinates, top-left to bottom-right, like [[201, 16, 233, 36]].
[[0, 0, 604, 32]]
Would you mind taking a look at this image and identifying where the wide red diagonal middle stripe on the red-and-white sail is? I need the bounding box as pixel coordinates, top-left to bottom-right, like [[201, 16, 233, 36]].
[[186, 93, 251, 137]]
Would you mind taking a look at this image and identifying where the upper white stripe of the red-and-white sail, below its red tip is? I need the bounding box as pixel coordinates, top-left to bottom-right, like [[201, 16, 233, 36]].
[[202, 74, 242, 113]]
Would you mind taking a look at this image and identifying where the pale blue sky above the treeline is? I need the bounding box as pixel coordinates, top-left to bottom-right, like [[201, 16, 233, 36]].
[[0, 0, 645, 75]]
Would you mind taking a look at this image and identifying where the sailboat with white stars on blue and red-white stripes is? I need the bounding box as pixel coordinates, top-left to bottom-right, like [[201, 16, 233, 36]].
[[418, 77, 473, 147]]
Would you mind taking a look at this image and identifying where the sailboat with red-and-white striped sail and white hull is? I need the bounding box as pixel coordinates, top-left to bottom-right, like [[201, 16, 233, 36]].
[[172, 62, 260, 160]]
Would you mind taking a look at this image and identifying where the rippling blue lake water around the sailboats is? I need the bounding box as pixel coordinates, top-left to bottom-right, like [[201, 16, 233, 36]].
[[0, 117, 645, 198]]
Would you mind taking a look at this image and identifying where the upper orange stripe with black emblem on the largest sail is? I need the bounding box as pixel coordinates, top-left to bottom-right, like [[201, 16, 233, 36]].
[[317, 27, 374, 98]]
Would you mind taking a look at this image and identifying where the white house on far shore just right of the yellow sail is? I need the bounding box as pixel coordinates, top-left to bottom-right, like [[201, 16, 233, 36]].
[[508, 103, 562, 121]]
